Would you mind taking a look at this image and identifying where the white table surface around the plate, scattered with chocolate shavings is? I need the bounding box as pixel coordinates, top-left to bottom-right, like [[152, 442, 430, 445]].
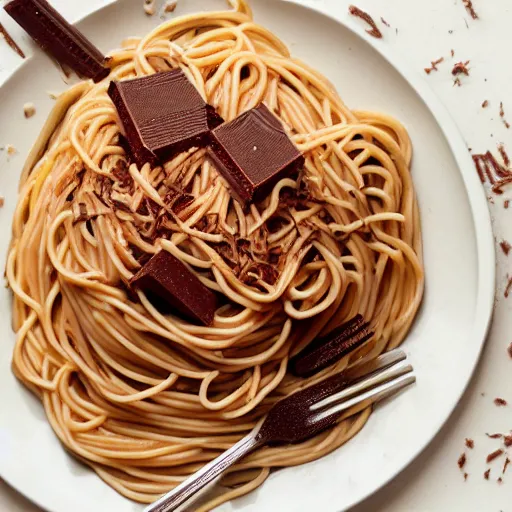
[[0, 0, 512, 512]]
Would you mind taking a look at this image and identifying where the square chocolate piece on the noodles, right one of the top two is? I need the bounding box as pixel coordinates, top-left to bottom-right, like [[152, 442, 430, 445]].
[[209, 104, 304, 203]]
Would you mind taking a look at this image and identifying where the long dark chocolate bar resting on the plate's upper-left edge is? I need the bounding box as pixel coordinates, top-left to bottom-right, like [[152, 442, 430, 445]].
[[4, 0, 110, 82]]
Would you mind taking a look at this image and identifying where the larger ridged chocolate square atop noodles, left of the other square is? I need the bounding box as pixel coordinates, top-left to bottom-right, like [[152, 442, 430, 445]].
[[108, 69, 223, 167]]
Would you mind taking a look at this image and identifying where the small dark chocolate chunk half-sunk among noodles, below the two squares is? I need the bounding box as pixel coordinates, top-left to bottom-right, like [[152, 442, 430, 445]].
[[130, 250, 217, 325]]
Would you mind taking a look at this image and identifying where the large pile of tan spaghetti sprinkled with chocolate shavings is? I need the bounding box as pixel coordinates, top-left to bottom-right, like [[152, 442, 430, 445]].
[[7, 0, 423, 510]]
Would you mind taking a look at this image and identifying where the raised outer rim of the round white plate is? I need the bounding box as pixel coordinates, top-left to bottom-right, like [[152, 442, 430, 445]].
[[0, 0, 496, 512]]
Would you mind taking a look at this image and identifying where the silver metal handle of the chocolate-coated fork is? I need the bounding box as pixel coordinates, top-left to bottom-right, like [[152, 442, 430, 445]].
[[144, 431, 262, 512]]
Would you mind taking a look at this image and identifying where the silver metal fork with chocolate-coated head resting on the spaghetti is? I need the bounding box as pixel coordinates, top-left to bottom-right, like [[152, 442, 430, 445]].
[[144, 350, 416, 512]]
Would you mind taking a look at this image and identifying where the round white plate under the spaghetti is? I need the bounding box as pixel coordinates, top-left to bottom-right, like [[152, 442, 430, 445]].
[[0, 0, 494, 512]]
